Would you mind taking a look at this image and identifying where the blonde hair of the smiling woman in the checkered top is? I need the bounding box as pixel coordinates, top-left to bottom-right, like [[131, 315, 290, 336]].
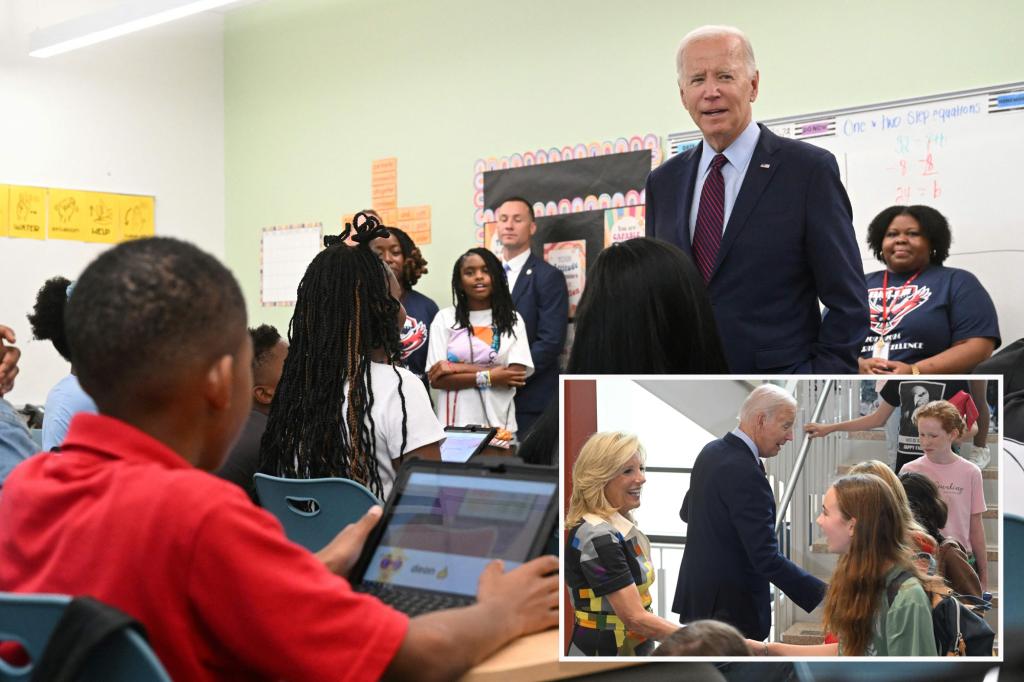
[[565, 431, 646, 528]]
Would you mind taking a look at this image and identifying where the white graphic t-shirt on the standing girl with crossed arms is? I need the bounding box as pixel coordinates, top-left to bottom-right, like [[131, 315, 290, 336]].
[[427, 307, 534, 433]]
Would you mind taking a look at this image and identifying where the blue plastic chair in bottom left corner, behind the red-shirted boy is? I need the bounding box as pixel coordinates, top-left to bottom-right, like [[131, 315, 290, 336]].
[[0, 592, 171, 682]]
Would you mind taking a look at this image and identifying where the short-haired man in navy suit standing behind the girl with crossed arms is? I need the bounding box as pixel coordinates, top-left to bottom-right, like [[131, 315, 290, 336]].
[[496, 197, 573, 440]]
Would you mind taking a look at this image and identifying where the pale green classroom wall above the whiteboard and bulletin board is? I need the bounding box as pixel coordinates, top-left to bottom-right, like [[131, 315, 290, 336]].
[[224, 0, 1024, 326]]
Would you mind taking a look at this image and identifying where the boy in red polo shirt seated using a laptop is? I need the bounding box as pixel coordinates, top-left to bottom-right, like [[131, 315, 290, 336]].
[[0, 239, 558, 681]]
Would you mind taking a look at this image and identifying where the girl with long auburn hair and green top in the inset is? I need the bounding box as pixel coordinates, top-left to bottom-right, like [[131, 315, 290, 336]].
[[748, 474, 948, 656]]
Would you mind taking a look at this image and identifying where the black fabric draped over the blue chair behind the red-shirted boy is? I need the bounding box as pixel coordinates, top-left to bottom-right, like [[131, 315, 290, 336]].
[[32, 597, 145, 682]]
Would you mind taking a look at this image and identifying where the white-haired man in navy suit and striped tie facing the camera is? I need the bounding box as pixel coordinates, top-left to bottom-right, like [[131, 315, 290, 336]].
[[646, 27, 868, 374]]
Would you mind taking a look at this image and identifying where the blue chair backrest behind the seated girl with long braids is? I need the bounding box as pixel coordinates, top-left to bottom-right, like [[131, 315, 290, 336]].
[[254, 473, 381, 552]]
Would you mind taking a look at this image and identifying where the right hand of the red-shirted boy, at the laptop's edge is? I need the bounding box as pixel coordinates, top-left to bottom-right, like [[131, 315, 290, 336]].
[[476, 554, 558, 638]]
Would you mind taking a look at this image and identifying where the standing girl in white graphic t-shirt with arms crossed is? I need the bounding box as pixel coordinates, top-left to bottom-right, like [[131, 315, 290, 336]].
[[427, 248, 534, 437]]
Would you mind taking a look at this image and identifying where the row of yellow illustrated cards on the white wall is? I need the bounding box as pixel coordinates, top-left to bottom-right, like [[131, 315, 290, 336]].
[[0, 184, 157, 244]]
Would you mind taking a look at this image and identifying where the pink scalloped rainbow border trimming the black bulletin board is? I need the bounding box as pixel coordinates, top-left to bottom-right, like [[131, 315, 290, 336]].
[[473, 133, 663, 228]]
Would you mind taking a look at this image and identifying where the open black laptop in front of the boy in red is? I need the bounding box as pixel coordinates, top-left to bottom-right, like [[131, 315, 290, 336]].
[[351, 460, 558, 615]]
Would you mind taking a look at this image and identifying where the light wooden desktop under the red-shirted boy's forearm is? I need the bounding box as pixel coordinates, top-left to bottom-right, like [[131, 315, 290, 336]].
[[461, 630, 637, 682]]
